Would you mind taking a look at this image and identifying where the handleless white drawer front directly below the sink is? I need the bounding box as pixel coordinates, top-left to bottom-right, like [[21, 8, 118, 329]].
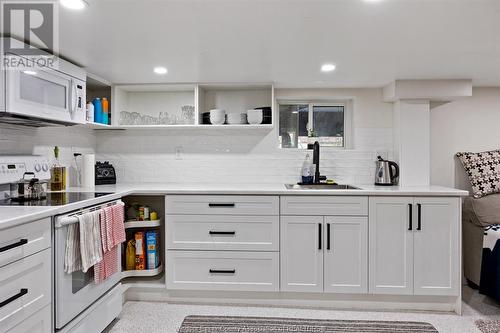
[[281, 195, 368, 216]]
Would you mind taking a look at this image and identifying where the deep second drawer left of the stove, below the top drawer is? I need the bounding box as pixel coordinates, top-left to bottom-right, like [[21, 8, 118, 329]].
[[0, 249, 51, 332]]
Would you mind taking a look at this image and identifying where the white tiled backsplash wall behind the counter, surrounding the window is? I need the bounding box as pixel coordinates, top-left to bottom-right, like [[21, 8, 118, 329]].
[[0, 89, 393, 184]]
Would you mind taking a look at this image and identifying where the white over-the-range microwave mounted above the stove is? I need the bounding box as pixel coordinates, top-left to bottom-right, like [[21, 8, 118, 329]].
[[0, 39, 86, 126]]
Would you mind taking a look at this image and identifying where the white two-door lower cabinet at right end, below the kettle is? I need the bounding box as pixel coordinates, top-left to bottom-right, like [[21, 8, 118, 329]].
[[369, 197, 460, 296]]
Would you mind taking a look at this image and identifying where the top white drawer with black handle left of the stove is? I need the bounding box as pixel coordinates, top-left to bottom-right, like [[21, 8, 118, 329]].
[[0, 218, 51, 267]]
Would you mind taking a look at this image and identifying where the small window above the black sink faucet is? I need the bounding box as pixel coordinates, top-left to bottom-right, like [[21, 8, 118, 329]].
[[279, 102, 347, 149]]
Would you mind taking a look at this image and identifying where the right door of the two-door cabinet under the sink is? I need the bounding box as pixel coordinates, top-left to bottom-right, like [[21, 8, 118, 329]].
[[324, 216, 368, 294]]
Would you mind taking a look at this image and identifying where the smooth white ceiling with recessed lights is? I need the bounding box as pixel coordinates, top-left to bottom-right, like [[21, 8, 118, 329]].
[[52, 0, 500, 87]]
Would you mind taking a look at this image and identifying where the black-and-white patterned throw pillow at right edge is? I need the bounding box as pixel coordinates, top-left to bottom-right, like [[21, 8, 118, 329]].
[[457, 150, 500, 198]]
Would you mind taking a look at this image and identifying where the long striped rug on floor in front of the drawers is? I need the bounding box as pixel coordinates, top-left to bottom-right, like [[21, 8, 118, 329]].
[[178, 316, 438, 333]]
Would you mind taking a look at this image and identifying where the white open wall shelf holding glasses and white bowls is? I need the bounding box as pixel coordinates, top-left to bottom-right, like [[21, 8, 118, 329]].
[[91, 83, 274, 130]]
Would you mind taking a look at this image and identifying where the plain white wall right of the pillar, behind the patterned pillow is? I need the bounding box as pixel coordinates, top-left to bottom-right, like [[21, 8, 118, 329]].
[[431, 88, 500, 187]]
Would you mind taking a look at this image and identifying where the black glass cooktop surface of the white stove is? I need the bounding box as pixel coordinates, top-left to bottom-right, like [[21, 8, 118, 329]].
[[0, 192, 113, 206]]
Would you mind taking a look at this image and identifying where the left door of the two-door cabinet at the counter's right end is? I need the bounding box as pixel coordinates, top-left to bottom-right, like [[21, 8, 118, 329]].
[[369, 197, 413, 295]]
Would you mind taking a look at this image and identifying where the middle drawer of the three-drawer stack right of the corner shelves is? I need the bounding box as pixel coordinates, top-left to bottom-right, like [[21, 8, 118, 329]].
[[166, 215, 279, 251]]
